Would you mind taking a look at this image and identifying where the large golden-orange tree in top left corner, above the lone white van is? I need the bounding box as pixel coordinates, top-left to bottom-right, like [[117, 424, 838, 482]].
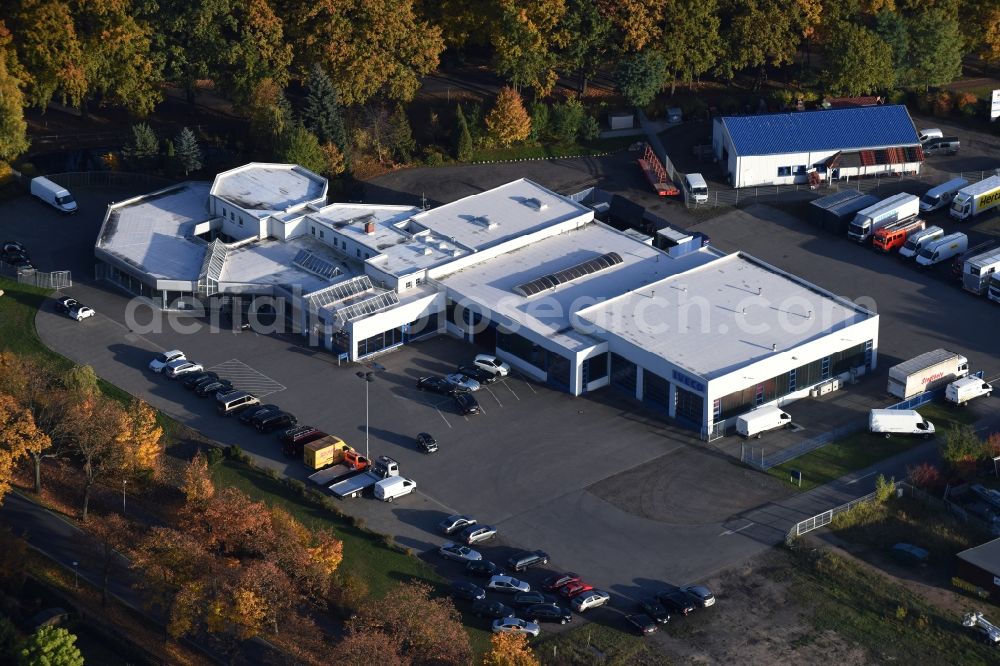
[[11, 0, 87, 109]]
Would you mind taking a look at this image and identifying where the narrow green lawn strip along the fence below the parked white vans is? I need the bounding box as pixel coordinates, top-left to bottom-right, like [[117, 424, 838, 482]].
[[767, 403, 975, 491]]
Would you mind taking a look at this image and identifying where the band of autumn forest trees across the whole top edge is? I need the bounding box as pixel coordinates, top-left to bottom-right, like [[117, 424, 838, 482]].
[[0, 0, 1000, 170]]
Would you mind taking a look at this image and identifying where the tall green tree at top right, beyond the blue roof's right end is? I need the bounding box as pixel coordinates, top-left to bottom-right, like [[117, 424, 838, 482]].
[[905, 5, 963, 90]]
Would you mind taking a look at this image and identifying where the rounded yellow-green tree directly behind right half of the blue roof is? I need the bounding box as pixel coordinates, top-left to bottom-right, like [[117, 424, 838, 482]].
[[823, 23, 896, 96]]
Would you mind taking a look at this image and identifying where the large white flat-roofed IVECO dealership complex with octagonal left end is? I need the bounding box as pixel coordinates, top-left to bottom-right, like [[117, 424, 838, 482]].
[[95, 164, 878, 437]]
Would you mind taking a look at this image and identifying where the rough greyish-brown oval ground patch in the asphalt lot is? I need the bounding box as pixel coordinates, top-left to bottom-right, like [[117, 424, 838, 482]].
[[588, 446, 790, 525]]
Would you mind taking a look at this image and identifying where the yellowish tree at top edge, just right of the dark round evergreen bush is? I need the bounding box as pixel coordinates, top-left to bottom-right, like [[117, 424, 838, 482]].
[[657, 0, 722, 95]]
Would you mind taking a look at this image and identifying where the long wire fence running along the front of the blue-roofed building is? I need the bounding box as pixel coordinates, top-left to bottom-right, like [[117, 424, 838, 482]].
[[682, 170, 996, 209]]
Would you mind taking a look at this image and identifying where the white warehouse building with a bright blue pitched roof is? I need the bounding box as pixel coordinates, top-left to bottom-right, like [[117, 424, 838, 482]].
[[712, 105, 924, 187]]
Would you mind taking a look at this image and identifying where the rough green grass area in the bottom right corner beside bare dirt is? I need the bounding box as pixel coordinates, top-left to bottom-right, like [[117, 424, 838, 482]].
[[789, 548, 997, 666]]
